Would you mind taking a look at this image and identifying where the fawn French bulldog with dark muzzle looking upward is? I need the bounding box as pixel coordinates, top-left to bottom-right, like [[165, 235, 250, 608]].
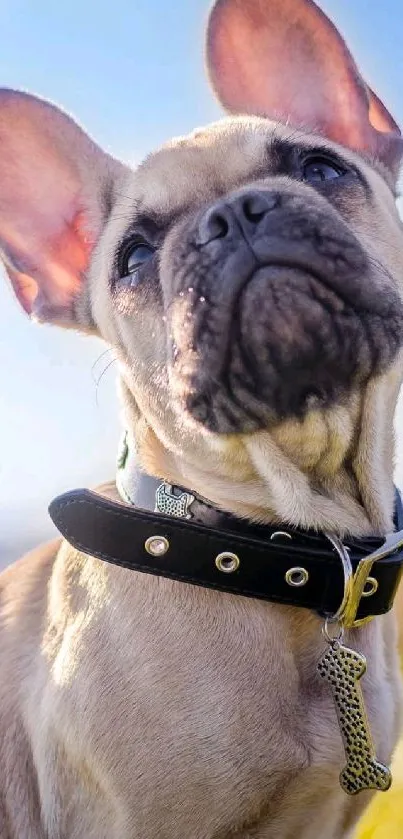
[[0, 0, 403, 839]]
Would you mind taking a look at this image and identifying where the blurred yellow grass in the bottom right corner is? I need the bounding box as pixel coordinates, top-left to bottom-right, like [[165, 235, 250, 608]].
[[355, 741, 403, 839]]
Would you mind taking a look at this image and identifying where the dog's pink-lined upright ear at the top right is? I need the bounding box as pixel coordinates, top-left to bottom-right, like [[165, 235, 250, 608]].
[[206, 0, 403, 182]]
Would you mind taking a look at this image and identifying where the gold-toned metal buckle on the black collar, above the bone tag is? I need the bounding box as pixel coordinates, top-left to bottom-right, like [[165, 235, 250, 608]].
[[325, 530, 403, 629]]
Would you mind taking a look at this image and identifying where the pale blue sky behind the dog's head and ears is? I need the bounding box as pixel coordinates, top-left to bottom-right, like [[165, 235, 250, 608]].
[[0, 0, 403, 560]]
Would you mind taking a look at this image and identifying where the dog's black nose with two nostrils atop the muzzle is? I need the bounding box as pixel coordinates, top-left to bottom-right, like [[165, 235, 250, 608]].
[[197, 189, 279, 246]]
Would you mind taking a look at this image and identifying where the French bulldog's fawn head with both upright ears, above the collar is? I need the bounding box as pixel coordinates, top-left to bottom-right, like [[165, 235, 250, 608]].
[[0, 0, 403, 532]]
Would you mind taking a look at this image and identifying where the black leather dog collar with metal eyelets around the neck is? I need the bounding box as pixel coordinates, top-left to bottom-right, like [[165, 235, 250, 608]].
[[49, 476, 403, 619]]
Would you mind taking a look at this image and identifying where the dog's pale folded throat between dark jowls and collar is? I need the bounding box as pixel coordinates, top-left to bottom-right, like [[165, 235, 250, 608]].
[[120, 370, 400, 538]]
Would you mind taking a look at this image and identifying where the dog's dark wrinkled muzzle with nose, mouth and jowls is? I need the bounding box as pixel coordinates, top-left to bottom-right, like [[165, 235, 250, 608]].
[[168, 189, 403, 433]]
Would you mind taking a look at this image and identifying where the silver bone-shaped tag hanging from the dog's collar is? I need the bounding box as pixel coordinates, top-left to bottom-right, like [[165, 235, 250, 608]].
[[318, 640, 392, 795]]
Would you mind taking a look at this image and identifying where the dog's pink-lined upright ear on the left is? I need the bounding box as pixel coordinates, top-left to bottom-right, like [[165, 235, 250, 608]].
[[0, 89, 119, 325]]
